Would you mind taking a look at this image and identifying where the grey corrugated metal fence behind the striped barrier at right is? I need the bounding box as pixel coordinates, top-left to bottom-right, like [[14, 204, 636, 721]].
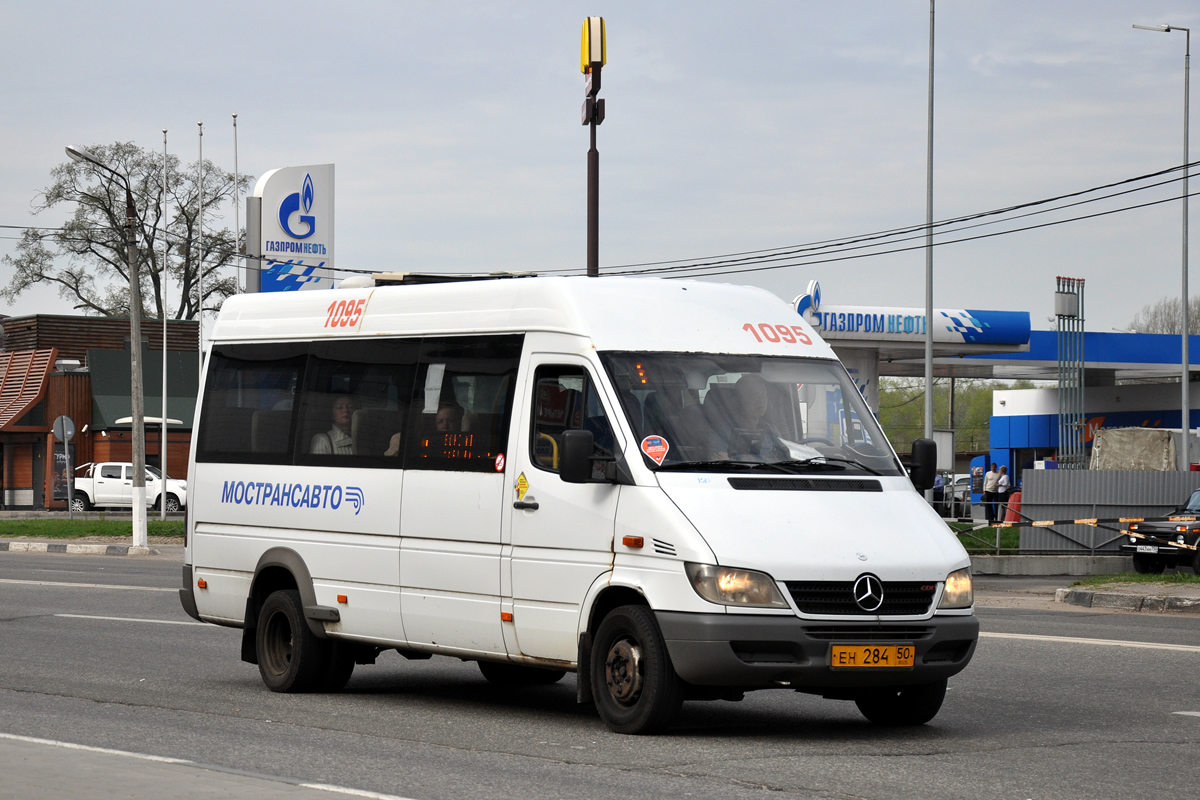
[[1020, 470, 1200, 553]]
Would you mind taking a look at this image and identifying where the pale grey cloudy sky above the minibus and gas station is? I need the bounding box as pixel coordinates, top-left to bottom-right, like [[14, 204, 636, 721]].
[[0, 0, 1200, 331]]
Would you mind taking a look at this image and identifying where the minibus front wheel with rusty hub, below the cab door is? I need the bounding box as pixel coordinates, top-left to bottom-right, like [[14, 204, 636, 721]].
[[592, 606, 684, 734]]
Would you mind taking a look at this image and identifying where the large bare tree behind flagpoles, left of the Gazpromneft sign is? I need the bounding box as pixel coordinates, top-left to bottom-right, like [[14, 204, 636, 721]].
[[0, 142, 253, 319]]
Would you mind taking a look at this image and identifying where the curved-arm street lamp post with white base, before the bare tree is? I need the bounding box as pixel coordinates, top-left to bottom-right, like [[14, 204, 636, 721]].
[[67, 145, 147, 547]]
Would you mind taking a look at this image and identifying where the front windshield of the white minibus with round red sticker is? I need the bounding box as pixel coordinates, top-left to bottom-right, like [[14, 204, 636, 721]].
[[600, 353, 905, 475]]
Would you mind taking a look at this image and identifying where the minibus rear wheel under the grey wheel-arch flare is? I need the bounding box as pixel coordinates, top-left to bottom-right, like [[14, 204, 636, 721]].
[[254, 589, 326, 692]]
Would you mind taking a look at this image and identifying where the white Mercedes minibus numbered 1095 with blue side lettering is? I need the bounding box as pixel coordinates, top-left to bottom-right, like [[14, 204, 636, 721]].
[[180, 275, 979, 733]]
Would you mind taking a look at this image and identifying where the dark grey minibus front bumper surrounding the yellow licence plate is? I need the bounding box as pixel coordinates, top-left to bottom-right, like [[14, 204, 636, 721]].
[[656, 612, 979, 692]]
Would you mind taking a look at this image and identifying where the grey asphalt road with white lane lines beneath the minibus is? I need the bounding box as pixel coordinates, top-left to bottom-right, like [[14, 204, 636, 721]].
[[0, 553, 1200, 800]]
